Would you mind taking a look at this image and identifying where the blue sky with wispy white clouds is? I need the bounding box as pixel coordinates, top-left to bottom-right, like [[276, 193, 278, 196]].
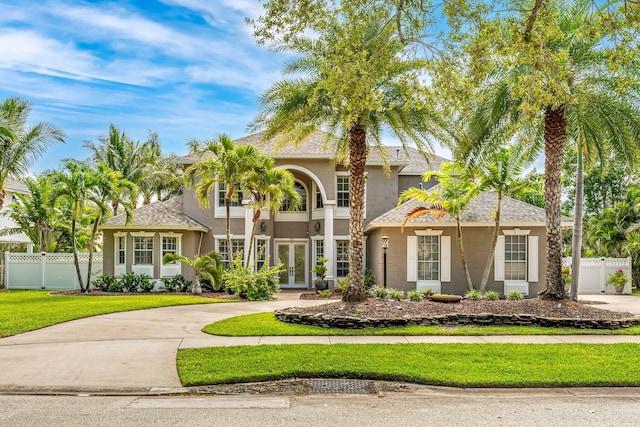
[[0, 0, 446, 172]]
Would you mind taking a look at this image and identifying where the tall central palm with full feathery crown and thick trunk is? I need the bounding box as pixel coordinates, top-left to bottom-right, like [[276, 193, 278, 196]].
[[250, 19, 440, 302]]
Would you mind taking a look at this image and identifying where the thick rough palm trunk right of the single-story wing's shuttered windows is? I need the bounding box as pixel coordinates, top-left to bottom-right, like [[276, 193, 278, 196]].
[[538, 105, 567, 301]]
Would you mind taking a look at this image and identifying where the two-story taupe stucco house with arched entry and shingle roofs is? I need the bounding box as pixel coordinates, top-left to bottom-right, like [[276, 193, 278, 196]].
[[102, 133, 570, 295]]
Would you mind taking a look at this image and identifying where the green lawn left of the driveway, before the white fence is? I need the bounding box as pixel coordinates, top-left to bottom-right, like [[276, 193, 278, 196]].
[[0, 291, 229, 337]]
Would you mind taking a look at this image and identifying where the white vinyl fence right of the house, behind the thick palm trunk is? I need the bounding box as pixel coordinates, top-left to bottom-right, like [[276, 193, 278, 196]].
[[562, 257, 631, 294]]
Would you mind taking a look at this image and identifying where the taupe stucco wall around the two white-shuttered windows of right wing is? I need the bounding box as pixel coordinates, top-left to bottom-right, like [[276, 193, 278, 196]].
[[367, 226, 546, 296]]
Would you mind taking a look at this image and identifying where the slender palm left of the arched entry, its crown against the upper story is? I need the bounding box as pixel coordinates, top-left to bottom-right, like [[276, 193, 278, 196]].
[[184, 134, 258, 266]]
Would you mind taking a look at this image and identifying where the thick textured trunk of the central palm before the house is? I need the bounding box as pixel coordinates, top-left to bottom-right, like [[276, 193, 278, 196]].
[[342, 119, 367, 302]]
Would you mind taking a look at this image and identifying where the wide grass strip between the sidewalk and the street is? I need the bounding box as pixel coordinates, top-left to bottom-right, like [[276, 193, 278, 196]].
[[178, 344, 640, 387]]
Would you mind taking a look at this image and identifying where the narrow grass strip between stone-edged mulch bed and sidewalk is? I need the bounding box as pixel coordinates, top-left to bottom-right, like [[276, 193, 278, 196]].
[[203, 313, 640, 337]]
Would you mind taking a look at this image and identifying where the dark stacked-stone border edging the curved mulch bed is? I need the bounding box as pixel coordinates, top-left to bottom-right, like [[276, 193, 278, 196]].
[[275, 310, 640, 329]]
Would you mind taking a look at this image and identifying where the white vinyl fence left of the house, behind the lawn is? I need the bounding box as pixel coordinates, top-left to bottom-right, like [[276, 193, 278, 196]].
[[4, 252, 103, 290]]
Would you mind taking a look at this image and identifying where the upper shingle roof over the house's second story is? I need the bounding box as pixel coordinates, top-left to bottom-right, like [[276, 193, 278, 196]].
[[177, 131, 446, 175]]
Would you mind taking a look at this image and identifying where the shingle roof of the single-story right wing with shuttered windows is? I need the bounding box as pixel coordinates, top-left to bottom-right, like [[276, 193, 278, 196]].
[[365, 191, 573, 231]]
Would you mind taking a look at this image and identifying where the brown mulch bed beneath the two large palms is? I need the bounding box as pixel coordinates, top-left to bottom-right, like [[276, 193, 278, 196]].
[[295, 298, 636, 320]]
